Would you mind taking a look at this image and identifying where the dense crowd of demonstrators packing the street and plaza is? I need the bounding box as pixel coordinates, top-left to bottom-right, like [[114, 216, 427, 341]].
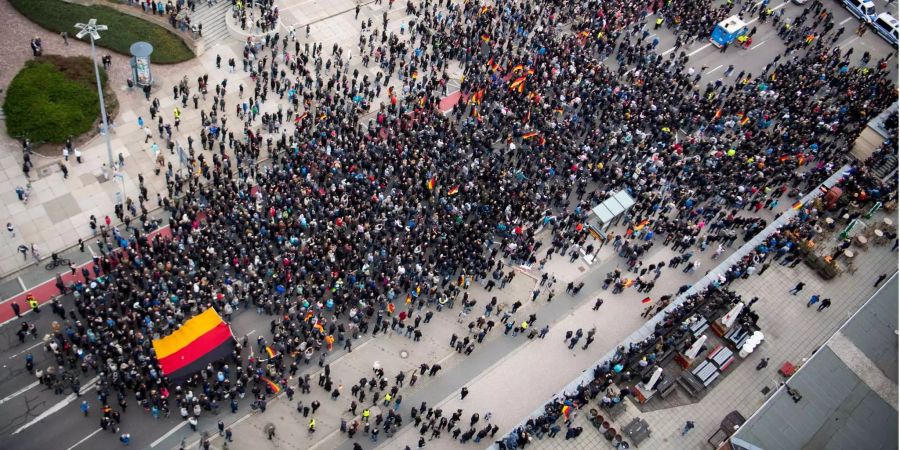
[[10, 0, 896, 448]]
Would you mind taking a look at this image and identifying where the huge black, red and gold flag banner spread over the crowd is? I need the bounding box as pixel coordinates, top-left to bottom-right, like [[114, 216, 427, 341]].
[[153, 308, 234, 380]]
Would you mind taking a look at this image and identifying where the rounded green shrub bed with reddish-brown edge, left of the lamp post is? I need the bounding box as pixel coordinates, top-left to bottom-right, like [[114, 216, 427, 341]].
[[3, 55, 115, 143]]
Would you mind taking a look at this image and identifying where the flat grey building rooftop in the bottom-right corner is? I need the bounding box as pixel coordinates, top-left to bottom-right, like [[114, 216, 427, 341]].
[[732, 275, 898, 450]]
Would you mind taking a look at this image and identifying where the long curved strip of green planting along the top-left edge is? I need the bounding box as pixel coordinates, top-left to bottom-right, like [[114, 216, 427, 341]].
[[9, 0, 194, 64]]
